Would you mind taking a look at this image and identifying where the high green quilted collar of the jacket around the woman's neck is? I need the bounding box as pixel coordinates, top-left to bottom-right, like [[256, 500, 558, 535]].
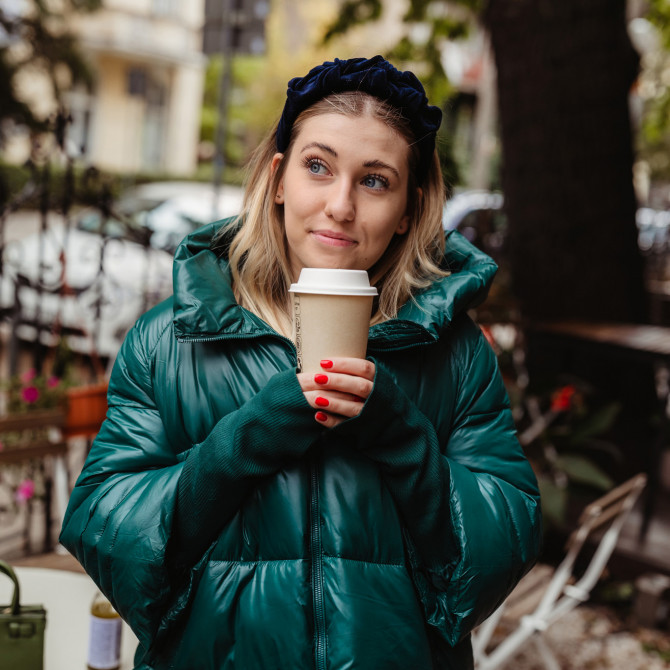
[[173, 220, 497, 350]]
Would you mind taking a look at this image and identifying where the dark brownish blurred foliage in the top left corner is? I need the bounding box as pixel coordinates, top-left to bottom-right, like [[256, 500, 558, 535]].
[[0, 0, 102, 146]]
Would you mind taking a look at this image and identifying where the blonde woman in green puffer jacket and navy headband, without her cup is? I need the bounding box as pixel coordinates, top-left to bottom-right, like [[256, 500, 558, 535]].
[[61, 56, 539, 670]]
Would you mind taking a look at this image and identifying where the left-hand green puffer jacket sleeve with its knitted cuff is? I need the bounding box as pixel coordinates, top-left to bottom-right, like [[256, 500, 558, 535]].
[[60, 326, 319, 649]]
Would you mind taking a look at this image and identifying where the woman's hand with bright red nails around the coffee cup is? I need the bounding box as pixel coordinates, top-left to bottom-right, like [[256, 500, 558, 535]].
[[298, 358, 375, 428]]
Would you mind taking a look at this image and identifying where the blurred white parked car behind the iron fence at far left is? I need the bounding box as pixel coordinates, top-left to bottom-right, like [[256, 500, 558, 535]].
[[0, 223, 172, 357]]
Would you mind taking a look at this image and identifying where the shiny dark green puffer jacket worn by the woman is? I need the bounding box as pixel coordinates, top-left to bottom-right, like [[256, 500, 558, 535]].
[[61, 224, 540, 670]]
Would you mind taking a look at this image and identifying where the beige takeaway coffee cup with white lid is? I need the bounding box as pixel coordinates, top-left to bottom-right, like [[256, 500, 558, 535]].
[[289, 268, 377, 372]]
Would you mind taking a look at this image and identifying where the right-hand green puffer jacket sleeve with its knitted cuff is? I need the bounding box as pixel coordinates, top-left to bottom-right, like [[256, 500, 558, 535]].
[[334, 320, 541, 646]]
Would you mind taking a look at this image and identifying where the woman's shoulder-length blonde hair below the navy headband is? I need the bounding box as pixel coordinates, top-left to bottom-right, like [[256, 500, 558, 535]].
[[220, 91, 448, 336]]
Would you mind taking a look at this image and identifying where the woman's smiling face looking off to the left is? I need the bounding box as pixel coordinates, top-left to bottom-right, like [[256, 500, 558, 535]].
[[272, 113, 409, 281]]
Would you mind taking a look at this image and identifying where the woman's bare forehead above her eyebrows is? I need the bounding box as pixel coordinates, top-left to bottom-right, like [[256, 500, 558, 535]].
[[294, 113, 409, 165]]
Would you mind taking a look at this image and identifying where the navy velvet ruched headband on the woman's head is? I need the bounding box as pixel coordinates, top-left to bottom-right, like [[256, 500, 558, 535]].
[[277, 56, 442, 179]]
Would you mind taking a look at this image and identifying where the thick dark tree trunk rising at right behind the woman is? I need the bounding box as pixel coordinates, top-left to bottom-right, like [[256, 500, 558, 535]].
[[484, 0, 647, 322]]
